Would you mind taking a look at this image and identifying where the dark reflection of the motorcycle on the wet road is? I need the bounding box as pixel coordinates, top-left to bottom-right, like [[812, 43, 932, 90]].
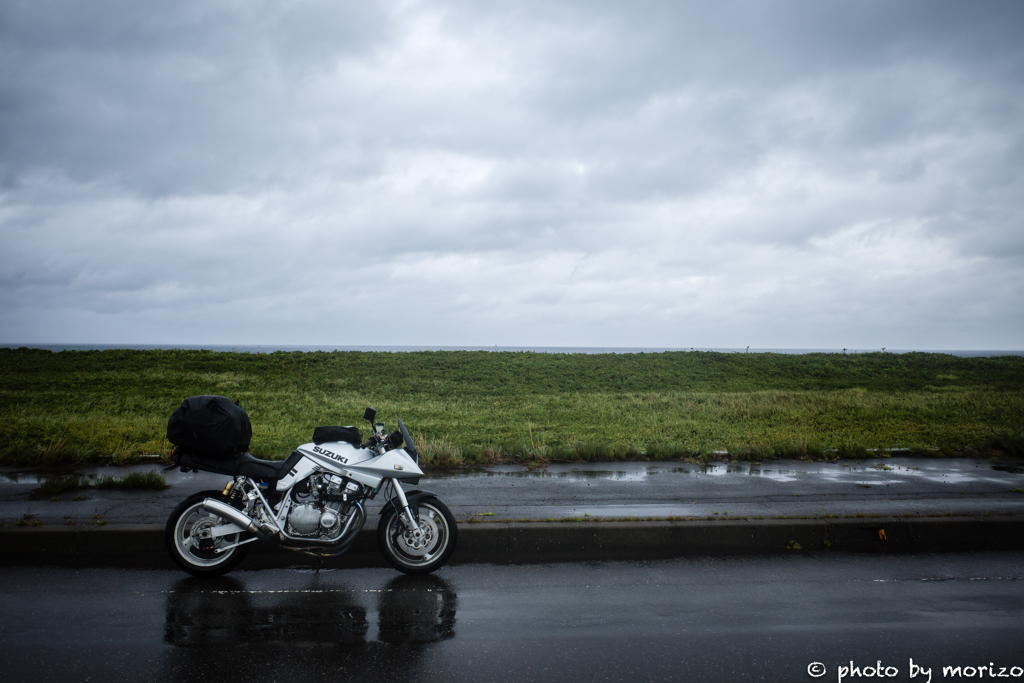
[[158, 572, 458, 683]]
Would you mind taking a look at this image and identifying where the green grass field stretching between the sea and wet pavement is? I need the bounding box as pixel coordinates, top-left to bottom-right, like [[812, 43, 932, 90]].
[[0, 349, 1024, 466]]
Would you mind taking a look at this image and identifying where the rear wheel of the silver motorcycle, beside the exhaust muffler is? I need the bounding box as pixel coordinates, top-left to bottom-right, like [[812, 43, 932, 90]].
[[164, 490, 251, 577]]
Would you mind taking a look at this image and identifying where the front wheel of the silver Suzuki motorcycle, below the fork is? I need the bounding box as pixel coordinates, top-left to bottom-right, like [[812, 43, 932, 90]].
[[377, 498, 459, 573]]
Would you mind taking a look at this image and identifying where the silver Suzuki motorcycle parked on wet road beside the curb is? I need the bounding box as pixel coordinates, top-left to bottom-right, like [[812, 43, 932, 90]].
[[164, 405, 458, 577]]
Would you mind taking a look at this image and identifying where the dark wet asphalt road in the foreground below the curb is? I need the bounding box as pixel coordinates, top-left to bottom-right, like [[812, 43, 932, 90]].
[[0, 553, 1024, 683]]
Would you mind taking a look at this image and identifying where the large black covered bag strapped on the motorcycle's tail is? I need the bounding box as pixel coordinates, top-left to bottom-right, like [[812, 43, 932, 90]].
[[167, 396, 253, 458]]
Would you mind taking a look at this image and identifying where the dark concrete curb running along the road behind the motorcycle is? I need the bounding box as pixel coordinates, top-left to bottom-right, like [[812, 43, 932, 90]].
[[0, 517, 1024, 569]]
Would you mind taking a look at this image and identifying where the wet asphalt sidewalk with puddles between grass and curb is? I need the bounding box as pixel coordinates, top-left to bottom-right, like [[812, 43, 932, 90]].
[[0, 458, 1024, 526]]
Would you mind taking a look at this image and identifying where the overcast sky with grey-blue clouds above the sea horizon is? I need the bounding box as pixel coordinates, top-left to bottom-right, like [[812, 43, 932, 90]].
[[0, 0, 1024, 349]]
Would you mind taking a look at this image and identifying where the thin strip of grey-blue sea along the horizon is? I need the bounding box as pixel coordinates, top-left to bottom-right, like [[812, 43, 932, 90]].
[[0, 343, 1024, 357]]
